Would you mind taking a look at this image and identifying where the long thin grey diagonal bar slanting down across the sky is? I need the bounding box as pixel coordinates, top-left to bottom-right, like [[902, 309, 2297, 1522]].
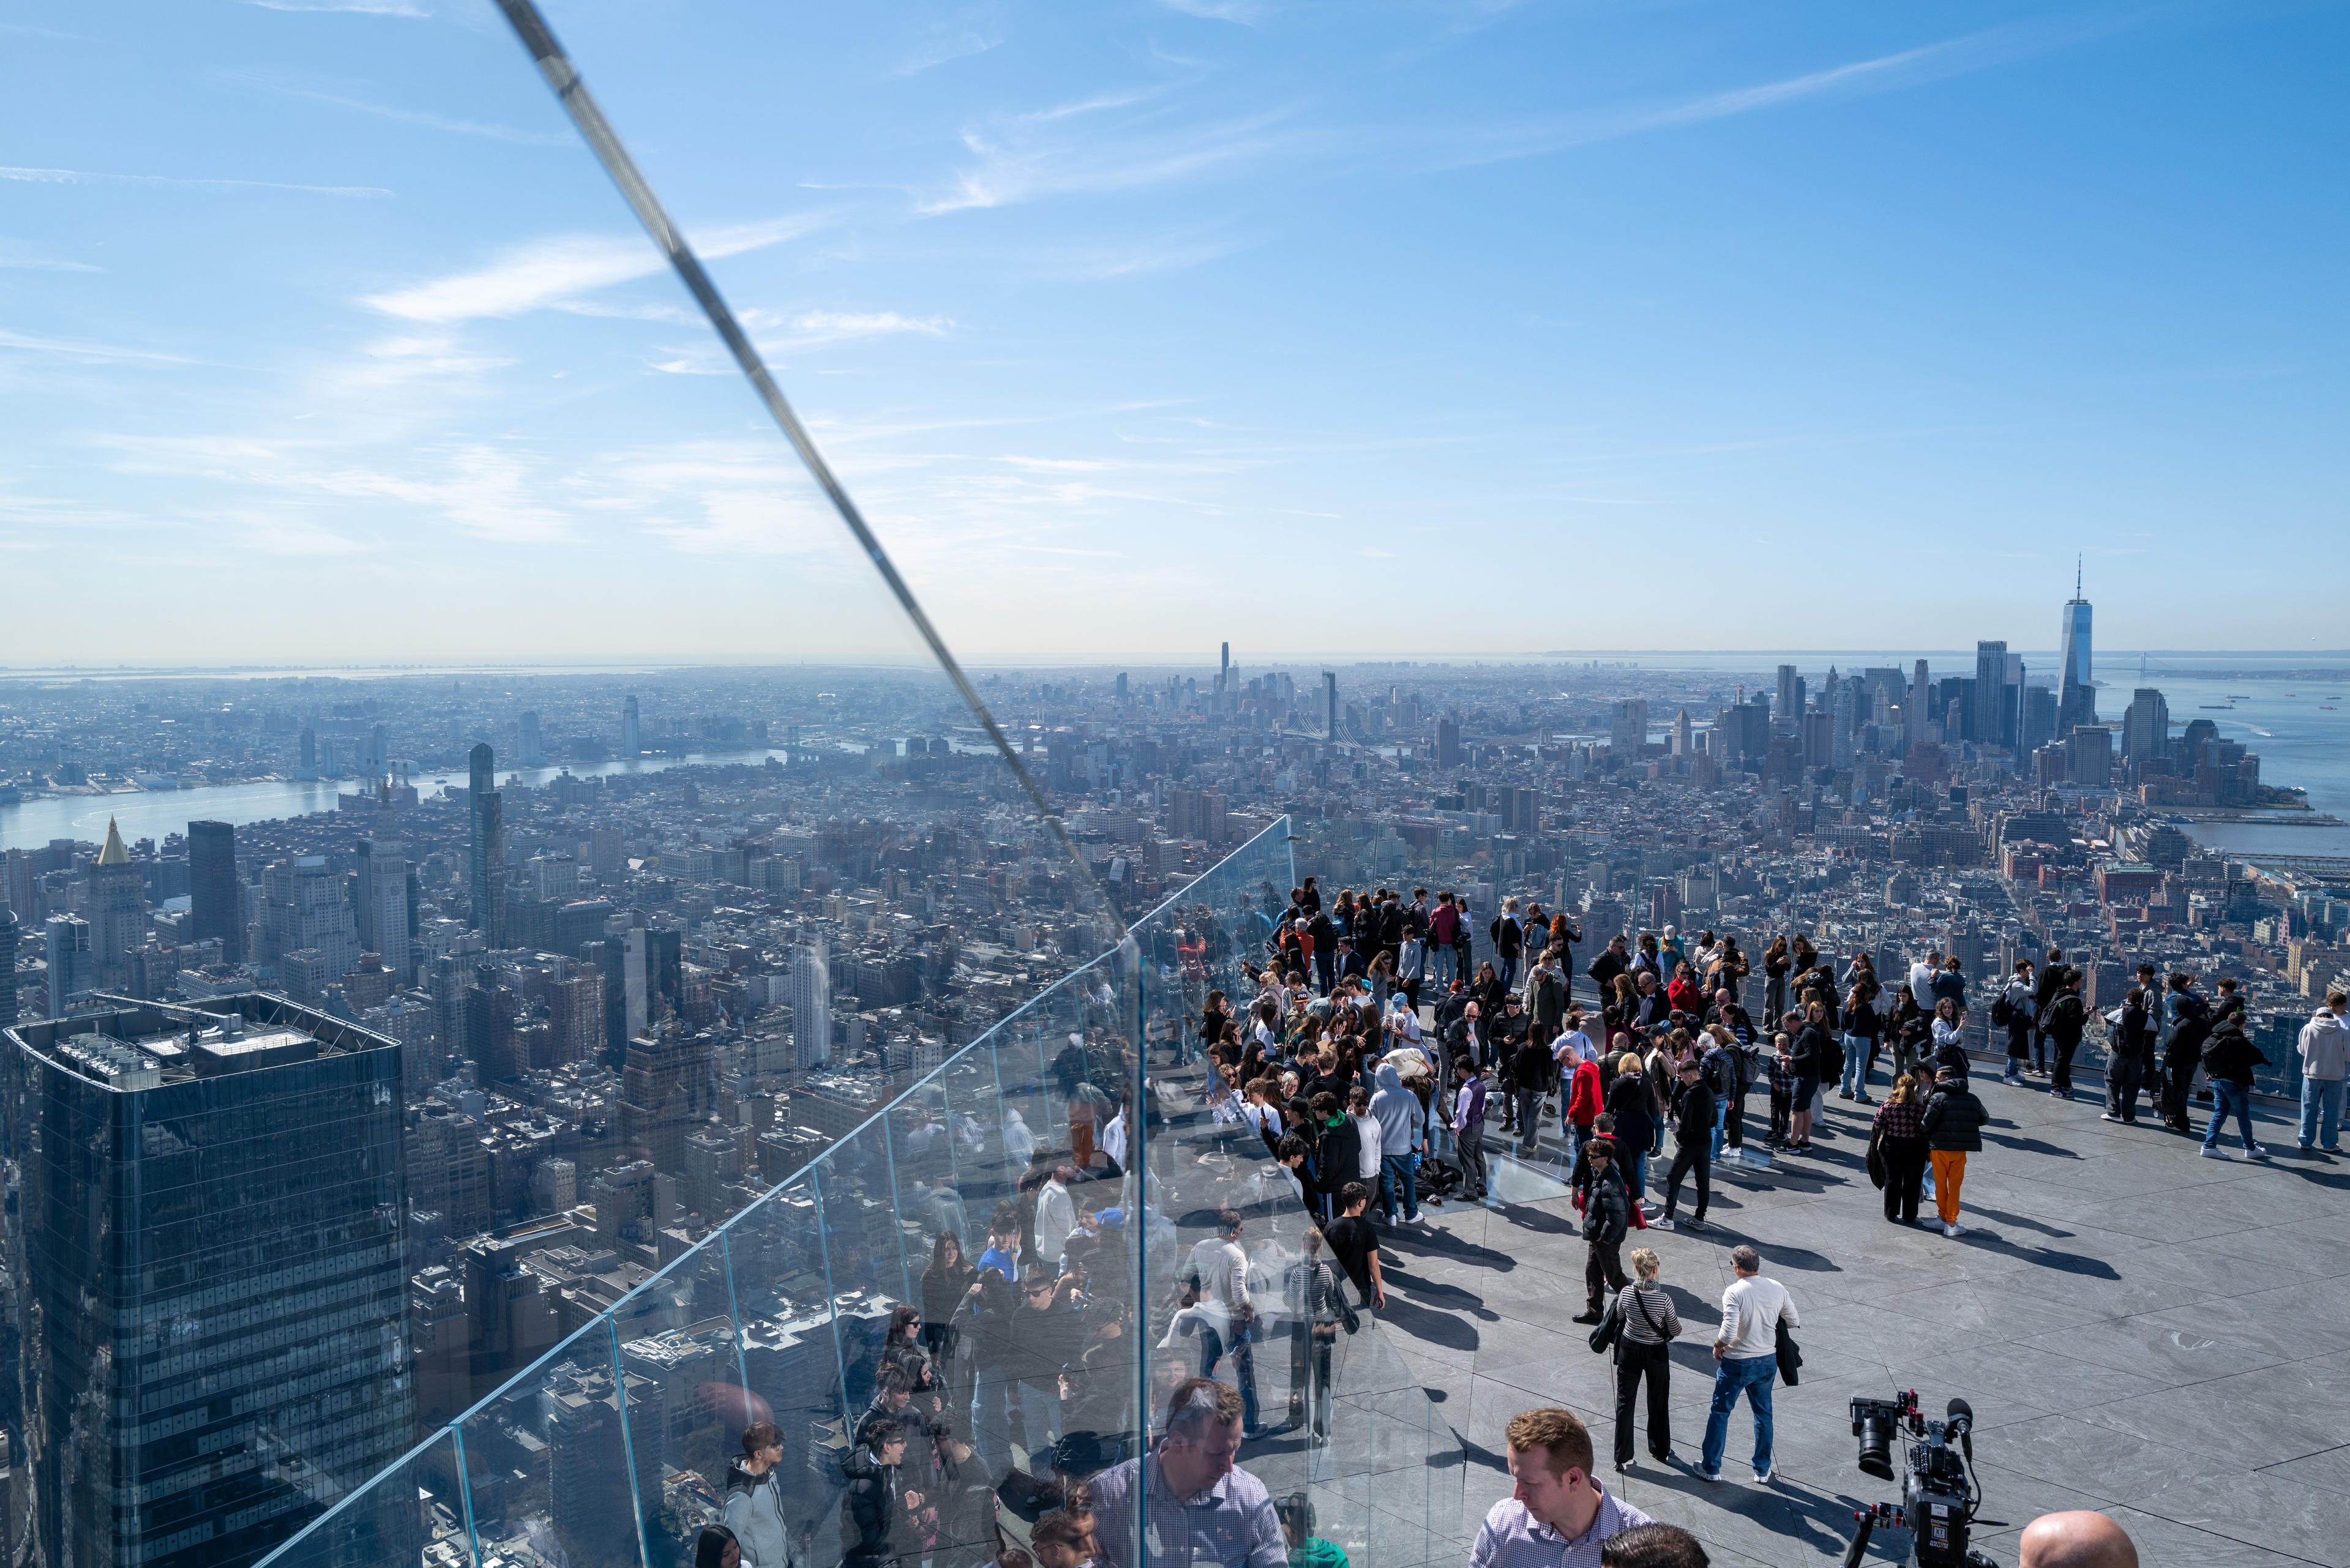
[[498, 0, 1126, 938]]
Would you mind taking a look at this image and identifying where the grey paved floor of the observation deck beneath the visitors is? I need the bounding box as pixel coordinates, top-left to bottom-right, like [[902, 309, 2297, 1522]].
[[1379, 1077, 2350, 1568]]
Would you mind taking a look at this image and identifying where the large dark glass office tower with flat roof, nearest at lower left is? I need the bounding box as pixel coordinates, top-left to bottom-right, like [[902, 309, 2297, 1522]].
[[0, 995, 423, 1568]]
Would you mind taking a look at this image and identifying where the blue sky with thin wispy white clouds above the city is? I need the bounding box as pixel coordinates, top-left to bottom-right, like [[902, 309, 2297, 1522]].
[[0, 0, 2350, 665]]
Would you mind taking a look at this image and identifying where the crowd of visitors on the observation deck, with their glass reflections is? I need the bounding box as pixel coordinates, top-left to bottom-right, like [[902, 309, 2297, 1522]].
[[672, 879, 2350, 1568]]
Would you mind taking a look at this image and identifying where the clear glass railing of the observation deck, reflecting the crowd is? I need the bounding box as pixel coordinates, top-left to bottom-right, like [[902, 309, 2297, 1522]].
[[263, 818, 1462, 1568]]
